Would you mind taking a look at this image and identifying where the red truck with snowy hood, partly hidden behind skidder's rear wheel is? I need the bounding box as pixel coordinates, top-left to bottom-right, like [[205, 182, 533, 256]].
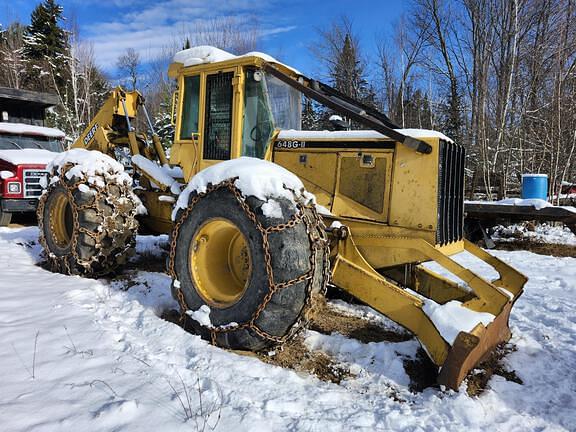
[[0, 122, 64, 226]]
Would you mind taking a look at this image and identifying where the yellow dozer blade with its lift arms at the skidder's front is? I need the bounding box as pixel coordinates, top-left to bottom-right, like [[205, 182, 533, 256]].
[[332, 233, 527, 390]]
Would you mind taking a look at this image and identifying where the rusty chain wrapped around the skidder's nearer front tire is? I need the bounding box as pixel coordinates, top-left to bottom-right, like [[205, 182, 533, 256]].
[[168, 178, 330, 345]]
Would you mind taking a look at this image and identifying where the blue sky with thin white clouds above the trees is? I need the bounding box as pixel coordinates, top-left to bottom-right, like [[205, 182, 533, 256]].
[[0, 0, 409, 76]]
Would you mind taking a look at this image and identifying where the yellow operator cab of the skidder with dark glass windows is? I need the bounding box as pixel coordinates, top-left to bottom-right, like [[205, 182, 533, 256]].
[[169, 47, 302, 177]]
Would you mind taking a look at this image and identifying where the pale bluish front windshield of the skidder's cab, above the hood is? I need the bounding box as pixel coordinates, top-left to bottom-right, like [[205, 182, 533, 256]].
[[266, 74, 302, 130]]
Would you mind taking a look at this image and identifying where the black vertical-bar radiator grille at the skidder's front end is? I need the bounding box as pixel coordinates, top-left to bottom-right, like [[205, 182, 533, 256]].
[[436, 141, 465, 245]]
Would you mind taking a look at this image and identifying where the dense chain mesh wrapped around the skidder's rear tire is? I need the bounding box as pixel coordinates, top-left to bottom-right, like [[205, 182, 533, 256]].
[[36, 164, 138, 277]]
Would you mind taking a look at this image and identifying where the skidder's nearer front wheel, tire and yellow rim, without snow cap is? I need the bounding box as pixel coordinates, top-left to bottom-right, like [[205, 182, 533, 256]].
[[169, 180, 329, 351]]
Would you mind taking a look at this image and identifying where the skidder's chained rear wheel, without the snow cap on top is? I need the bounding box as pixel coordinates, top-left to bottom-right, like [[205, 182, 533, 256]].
[[37, 165, 138, 277]]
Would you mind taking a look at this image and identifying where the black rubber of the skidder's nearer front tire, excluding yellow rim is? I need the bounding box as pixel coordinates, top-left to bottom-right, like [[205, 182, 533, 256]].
[[169, 182, 329, 351]]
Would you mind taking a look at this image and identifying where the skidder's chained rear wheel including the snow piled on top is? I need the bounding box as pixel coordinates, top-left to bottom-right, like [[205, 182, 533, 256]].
[[37, 149, 141, 276]]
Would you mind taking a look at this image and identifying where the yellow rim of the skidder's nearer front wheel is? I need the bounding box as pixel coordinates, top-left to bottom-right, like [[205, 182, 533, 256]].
[[189, 218, 252, 308]]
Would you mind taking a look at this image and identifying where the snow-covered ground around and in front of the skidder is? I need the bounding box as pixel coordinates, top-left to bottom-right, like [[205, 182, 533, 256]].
[[0, 228, 576, 432]]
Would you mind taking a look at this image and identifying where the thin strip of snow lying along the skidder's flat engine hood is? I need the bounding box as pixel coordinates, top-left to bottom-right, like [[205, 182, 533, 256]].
[[278, 129, 454, 143]]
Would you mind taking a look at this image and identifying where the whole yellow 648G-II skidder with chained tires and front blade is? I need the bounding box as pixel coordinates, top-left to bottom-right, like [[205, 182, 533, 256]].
[[38, 47, 526, 389]]
